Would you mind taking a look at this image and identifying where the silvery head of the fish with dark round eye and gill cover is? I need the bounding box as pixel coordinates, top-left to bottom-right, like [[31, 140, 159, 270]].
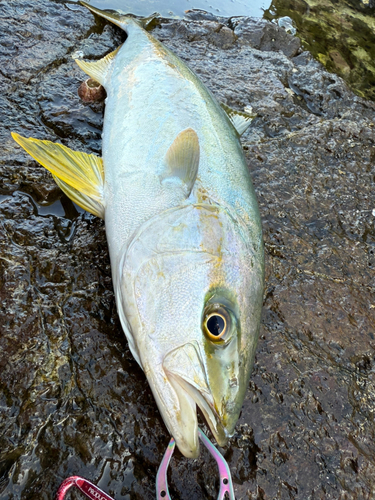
[[119, 205, 263, 457]]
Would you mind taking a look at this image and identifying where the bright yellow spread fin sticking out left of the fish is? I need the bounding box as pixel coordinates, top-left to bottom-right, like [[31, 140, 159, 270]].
[[12, 132, 104, 218]]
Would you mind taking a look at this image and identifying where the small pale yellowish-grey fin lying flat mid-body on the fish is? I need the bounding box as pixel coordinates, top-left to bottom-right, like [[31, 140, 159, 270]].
[[162, 128, 199, 197]]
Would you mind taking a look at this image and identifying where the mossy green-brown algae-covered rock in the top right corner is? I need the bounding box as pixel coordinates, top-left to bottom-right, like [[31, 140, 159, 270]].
[[264, 0, 375, 101]]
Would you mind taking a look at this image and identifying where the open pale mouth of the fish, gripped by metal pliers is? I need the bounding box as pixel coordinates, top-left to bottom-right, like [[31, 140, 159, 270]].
[[163, 342, 229, 458]]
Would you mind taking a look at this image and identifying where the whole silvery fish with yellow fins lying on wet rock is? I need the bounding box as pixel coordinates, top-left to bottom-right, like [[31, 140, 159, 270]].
[[12, 2, 264, 458]]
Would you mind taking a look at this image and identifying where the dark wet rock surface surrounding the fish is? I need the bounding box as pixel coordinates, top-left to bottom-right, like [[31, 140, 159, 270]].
[[0, 0, 375, 500]]
